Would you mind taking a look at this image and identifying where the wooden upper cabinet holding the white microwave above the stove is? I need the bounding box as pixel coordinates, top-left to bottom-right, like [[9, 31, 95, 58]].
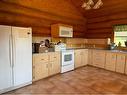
[[51, 24, 73, 38]]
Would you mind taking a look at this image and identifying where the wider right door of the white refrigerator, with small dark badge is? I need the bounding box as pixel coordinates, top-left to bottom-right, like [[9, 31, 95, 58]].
[[12, 27, 32, 86]]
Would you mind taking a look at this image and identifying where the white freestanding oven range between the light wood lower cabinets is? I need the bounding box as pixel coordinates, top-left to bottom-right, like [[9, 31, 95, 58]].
[[61, 50, 74, 73]]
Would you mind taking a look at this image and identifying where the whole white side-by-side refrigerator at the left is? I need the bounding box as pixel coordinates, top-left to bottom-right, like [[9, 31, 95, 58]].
[[0, 25, 32, 93]]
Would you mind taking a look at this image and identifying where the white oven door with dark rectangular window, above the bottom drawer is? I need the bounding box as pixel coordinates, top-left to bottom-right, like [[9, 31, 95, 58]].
[[62, 50, 74, 66]]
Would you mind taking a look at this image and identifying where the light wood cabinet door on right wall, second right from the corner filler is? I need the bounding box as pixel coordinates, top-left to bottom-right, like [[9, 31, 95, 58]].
[[105, 52, 117, 71]]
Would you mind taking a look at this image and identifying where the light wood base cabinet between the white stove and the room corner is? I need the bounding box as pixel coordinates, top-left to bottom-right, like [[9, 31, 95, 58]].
[[74, 49, 88, 68]]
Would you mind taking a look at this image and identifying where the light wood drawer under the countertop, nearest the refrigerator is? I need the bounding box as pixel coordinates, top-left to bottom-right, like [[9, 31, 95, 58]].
[[34, 53, 49, 63]]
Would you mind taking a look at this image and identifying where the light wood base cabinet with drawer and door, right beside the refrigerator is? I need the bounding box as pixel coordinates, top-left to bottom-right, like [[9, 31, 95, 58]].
[[33, 53, 49, 81]]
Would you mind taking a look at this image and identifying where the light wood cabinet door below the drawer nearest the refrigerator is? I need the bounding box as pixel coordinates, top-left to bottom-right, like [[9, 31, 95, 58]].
[[34, 63, 48, 80]]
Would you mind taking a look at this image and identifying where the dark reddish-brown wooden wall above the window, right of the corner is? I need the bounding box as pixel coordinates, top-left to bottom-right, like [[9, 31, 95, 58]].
[[84, 0, 127, 40]]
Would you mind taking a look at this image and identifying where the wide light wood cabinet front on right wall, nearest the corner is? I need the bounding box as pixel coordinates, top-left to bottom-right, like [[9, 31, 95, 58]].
[[92, 50, 106, 68]]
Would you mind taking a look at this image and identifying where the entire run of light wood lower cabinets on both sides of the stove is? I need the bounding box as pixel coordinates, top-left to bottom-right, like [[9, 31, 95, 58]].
[[33, 49, 127, 81]]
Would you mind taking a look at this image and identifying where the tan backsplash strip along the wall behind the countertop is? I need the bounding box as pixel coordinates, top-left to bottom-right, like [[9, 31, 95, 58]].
[[32, 37, 107, 48]]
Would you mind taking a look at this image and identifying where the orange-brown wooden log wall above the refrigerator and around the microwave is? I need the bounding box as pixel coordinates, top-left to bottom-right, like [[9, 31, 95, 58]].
[[0, 0, 86, 37]]
